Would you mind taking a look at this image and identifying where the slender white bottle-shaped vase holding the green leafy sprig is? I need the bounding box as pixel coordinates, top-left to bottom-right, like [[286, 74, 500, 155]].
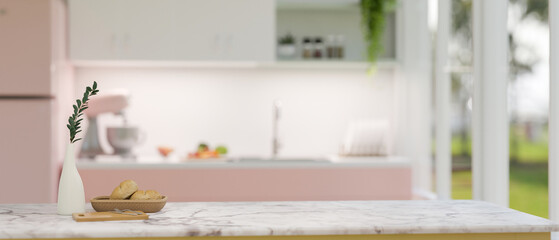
[[58, 143, 85, 215]]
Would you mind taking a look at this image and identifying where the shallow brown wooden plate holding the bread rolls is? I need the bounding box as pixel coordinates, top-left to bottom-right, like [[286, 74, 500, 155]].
[[91, 196, 167, 213]]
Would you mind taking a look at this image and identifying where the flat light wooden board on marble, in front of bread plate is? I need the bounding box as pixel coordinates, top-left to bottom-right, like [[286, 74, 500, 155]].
[[72, 209, 149, 222]]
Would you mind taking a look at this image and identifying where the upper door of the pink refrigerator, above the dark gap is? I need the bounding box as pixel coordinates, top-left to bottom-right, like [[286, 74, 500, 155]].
[[0, 0, 57, 96]]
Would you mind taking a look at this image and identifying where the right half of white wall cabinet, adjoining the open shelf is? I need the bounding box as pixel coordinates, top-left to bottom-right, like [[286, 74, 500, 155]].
[[171, 0, 276, 61]]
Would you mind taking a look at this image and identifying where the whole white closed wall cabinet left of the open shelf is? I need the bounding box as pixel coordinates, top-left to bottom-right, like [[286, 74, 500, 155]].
[[69, 0, 275, 61]]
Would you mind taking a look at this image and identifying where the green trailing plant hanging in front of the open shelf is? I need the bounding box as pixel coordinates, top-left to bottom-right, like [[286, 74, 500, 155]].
[[360, 0, 396, 63]]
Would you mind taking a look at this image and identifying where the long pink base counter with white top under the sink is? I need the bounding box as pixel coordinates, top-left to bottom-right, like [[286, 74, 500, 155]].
[[77, 157, 412, 202]]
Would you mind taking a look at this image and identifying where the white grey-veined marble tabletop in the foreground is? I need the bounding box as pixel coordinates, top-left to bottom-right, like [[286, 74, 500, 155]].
[[0, 200, 559, 238]]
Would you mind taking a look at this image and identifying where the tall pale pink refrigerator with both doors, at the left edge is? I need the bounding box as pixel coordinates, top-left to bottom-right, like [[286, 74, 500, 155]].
[[0, 0, 74, 203]]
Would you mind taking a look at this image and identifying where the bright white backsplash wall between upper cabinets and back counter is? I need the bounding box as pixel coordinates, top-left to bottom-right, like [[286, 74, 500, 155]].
[[76, 67, 394, 157]]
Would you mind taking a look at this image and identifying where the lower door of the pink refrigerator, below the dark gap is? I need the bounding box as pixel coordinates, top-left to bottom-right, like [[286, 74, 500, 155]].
[[0, 99, 58, 203]]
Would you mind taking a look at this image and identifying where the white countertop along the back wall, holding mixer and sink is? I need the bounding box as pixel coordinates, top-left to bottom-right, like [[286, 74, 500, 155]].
[[76, 156, 411, 169]]
